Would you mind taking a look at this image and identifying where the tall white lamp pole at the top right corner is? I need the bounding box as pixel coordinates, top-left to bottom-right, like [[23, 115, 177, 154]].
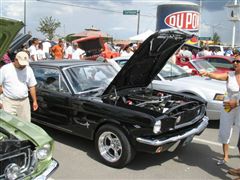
[[226, 0, 240, 48]]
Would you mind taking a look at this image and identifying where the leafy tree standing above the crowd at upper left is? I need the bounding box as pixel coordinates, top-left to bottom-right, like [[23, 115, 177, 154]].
[[37, 16, 61, 40]]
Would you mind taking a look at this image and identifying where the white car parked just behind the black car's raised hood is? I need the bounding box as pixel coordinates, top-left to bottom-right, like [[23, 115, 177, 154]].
[[113, 57, 226, 120]]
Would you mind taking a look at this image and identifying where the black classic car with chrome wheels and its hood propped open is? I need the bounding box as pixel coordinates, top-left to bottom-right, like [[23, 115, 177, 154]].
[[31, 31, 208, 168]]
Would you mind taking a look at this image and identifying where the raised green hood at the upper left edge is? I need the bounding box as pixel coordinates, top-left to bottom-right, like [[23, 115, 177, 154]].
[[0, 17, 24, 59]]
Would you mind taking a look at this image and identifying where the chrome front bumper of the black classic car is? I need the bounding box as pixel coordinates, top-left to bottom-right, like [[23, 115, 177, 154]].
[[136, 116, 209, 146]]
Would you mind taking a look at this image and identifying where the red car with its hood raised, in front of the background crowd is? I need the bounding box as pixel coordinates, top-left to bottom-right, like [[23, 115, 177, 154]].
[[73, 36, 120, 60]]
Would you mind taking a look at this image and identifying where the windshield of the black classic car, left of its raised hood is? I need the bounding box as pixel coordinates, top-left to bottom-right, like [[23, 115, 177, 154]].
[[65, 64, 117, 94]]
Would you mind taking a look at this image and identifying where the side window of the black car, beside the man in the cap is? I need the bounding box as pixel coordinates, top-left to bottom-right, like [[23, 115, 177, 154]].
[[32, 67, 69, 93]]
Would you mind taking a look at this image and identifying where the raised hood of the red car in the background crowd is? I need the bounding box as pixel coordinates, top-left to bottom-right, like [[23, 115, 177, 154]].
[[73, 36, 104, 51]]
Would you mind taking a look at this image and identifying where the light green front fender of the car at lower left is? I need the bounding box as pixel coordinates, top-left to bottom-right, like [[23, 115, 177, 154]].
[[0, 109, 52, 146]]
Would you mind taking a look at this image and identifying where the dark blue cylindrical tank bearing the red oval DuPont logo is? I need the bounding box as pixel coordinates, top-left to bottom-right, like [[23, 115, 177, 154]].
[[156, 1, 200, 32]]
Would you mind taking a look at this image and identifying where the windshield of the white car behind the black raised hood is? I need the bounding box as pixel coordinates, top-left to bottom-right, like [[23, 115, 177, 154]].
[[160, 62, 190, 79]]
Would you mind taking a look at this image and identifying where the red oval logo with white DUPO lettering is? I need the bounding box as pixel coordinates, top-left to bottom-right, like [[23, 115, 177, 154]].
[[164, 11, 199, 31]]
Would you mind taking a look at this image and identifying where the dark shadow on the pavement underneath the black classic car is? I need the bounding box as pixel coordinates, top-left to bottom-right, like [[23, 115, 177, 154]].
[[39, 124, 234, 179]]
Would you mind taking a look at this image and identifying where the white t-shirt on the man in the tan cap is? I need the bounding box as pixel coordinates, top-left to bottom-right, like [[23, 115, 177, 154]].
[[0, 63, 37, 99]]
